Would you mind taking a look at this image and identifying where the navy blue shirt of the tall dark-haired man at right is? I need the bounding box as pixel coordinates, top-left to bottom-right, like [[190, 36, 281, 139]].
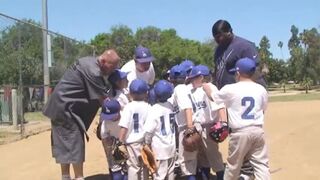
[[214, 36, 266, 89]]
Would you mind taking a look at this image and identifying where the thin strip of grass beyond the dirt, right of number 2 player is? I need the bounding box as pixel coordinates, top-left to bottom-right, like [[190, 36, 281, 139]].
[[269, 93, 320, 102]]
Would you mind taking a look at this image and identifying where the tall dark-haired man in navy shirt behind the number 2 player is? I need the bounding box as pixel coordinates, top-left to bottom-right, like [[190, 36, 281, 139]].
[[212, 20, 266, 89]]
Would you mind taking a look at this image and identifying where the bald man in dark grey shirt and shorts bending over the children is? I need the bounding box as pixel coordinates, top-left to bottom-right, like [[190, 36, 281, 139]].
[[43, 49, 120, 180]]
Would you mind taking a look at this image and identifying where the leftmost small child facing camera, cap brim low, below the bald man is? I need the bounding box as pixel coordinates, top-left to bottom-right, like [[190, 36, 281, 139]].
[[100, 99, 128, 180]]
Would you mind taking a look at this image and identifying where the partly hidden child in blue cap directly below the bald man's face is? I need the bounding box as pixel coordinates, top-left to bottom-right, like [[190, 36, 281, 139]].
[[108, 69, 129, 107]]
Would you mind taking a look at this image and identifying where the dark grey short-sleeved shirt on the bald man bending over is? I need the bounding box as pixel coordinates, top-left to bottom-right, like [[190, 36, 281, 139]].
[[43, 57, 110, 131]]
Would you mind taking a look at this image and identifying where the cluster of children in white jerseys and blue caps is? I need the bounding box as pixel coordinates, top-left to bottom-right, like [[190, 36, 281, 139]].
[[100, 59, 270, 180]]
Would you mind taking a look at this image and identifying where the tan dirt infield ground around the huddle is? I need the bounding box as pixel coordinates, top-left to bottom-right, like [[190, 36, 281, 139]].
[[0, 101, 320, 180]]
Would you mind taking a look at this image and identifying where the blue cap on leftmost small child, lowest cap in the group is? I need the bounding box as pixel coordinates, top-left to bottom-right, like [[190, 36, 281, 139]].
[[100, 98, 121, 120]]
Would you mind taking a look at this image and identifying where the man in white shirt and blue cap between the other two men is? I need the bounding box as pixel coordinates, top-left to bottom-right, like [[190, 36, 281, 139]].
[[121, 45, 155, 86]]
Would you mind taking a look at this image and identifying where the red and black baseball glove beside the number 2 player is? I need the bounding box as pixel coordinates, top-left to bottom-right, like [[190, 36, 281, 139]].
[[209, 121, 229, 143]]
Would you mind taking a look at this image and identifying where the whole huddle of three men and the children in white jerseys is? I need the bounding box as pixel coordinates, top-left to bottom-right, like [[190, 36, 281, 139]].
[[44, 20, 270, 180]]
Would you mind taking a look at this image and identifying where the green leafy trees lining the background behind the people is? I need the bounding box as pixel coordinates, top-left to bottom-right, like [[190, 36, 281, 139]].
[[0, 20, 320, 88]]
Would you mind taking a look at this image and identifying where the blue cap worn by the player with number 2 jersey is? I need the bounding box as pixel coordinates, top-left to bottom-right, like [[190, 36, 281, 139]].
[[229, 57, 256, 74]]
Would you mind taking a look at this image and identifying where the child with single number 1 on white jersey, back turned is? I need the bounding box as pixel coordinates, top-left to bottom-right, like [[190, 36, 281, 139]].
[[119, 79, 151, 180]]
